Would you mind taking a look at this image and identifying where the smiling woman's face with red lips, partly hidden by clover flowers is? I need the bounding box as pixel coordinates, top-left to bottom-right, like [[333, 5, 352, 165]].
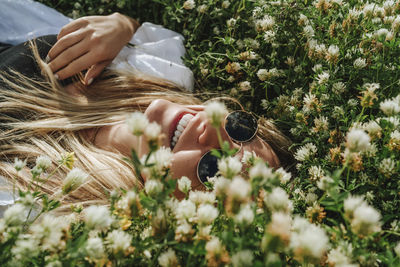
[[140, 99, 279, 189]]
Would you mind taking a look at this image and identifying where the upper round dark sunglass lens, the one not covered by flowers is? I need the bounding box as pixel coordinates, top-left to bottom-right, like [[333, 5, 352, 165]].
[[225, 111, 258, 142]]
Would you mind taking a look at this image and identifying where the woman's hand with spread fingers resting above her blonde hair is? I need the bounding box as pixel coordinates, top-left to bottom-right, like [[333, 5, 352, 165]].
[[48, 13, 139, 85]]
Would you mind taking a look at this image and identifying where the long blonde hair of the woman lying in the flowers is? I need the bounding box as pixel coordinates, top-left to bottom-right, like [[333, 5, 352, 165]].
[[0, 43, 290, 209]]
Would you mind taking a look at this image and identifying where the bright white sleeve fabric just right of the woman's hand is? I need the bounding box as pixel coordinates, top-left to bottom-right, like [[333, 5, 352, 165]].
[[110, 22, 194, 92]]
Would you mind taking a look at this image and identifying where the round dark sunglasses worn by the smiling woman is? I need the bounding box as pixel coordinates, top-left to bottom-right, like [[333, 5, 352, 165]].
[[197, 110, 258, 184]]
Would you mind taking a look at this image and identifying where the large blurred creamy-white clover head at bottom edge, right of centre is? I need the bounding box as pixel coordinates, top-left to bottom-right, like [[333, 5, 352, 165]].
[[290, 217, 329, 260]]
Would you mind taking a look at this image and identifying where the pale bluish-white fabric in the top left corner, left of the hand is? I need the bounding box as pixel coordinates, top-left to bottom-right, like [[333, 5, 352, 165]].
[[0, 0, 72, 45]]
